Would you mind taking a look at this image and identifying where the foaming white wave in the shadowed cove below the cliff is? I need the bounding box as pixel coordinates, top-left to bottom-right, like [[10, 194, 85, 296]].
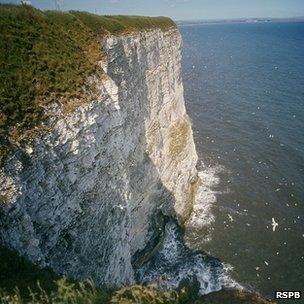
[[136, 221, 242, 295]]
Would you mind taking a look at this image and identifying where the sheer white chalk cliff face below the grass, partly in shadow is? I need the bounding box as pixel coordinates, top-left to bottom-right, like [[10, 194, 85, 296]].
[[0, 29, 197, 285]]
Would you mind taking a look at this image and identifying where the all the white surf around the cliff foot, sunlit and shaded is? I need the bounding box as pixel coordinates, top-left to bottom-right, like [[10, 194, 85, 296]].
[[136, 164, 243, 295]]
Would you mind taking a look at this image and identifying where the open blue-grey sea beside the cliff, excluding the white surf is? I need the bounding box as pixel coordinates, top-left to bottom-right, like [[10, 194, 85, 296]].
[[180, 23, 304, 297]]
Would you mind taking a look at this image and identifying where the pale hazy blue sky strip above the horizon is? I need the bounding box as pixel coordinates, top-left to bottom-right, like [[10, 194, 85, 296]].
[[0, 0, 304, 20]]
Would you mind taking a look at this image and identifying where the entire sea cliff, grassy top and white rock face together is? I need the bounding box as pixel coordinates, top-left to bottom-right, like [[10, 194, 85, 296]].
[[0, 6, 198, 286]]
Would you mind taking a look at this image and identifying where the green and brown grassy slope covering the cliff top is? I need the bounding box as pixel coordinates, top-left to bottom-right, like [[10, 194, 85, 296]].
[[0, 5, 176, 162]]
